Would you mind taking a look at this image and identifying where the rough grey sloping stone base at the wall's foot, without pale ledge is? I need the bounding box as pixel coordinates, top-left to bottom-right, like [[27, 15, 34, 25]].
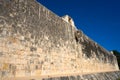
[[42, 71, 120, 80]]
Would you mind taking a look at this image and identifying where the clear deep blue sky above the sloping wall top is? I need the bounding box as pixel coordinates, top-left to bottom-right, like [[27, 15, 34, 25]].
[[37, 0, 120, 51]]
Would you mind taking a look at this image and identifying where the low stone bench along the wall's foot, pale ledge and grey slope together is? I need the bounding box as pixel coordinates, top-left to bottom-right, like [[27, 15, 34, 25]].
[[6, 71, 120, 80]]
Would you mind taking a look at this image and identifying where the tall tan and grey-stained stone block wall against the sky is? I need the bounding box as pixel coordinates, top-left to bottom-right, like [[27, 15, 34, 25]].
[[0, 0, 118, 78]]
